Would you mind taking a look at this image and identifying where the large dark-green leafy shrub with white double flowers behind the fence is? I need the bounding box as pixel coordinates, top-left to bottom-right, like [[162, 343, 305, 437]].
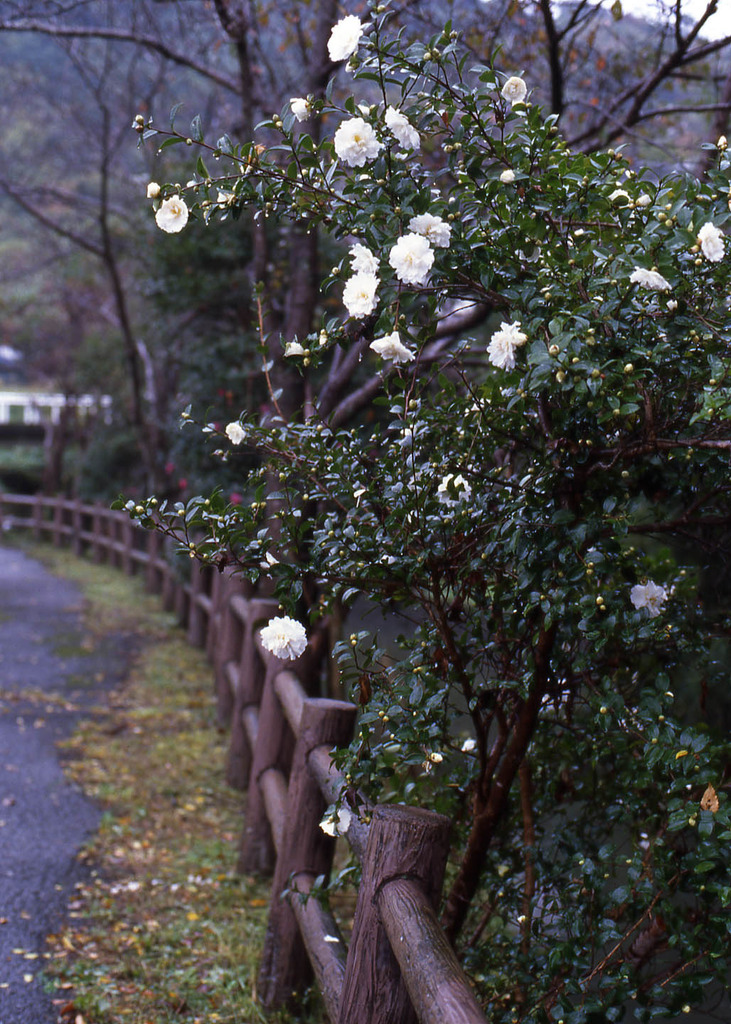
[[128, 5, 731, 1024]]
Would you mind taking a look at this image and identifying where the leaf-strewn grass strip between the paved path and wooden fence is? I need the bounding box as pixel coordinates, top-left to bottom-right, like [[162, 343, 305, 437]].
[[14, 548, 323, 1024]]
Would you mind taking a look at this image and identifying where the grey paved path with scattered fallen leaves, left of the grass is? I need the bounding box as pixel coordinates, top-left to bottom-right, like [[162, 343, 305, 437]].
[[0, 547, 129, 1024]]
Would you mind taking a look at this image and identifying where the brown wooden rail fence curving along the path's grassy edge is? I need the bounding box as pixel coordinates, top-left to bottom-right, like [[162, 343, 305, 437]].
[[0, 495, 485, 1024]]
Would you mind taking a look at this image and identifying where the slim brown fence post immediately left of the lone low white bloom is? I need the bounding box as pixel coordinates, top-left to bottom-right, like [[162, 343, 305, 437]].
[[226, 598, 280, 790]]
